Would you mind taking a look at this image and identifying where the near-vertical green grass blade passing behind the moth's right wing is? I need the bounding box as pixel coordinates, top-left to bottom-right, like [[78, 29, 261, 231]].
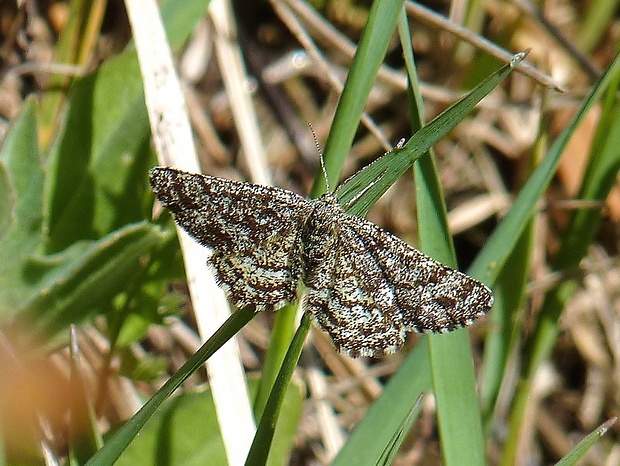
[[405, 10, 486, 465]]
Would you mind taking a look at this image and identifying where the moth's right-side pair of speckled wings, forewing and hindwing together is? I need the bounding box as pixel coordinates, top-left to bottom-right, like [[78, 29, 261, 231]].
[[304, 195, 493, 357]]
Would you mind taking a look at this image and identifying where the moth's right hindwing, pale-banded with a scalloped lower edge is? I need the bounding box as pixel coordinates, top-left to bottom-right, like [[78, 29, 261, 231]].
[[303, 196, 406, 357]]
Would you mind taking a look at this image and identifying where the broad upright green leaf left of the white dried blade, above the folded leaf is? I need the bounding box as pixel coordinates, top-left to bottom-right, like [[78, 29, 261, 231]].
[[47, 53, 150, 252]]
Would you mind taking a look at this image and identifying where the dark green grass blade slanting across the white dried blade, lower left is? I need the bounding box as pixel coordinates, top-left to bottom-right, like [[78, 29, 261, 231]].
[[86, 308, 256, 466]]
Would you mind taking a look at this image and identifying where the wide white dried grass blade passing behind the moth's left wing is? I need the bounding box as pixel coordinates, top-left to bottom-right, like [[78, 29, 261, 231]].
[[126, 0, 255, 465]]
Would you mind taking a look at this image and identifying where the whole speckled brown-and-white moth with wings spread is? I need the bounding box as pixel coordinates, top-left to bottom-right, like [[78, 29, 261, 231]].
[[150, 168, 493, 357]]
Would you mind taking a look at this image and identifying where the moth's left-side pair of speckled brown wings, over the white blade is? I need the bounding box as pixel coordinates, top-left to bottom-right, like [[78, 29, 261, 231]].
[[150, 167, 312, 310]]
